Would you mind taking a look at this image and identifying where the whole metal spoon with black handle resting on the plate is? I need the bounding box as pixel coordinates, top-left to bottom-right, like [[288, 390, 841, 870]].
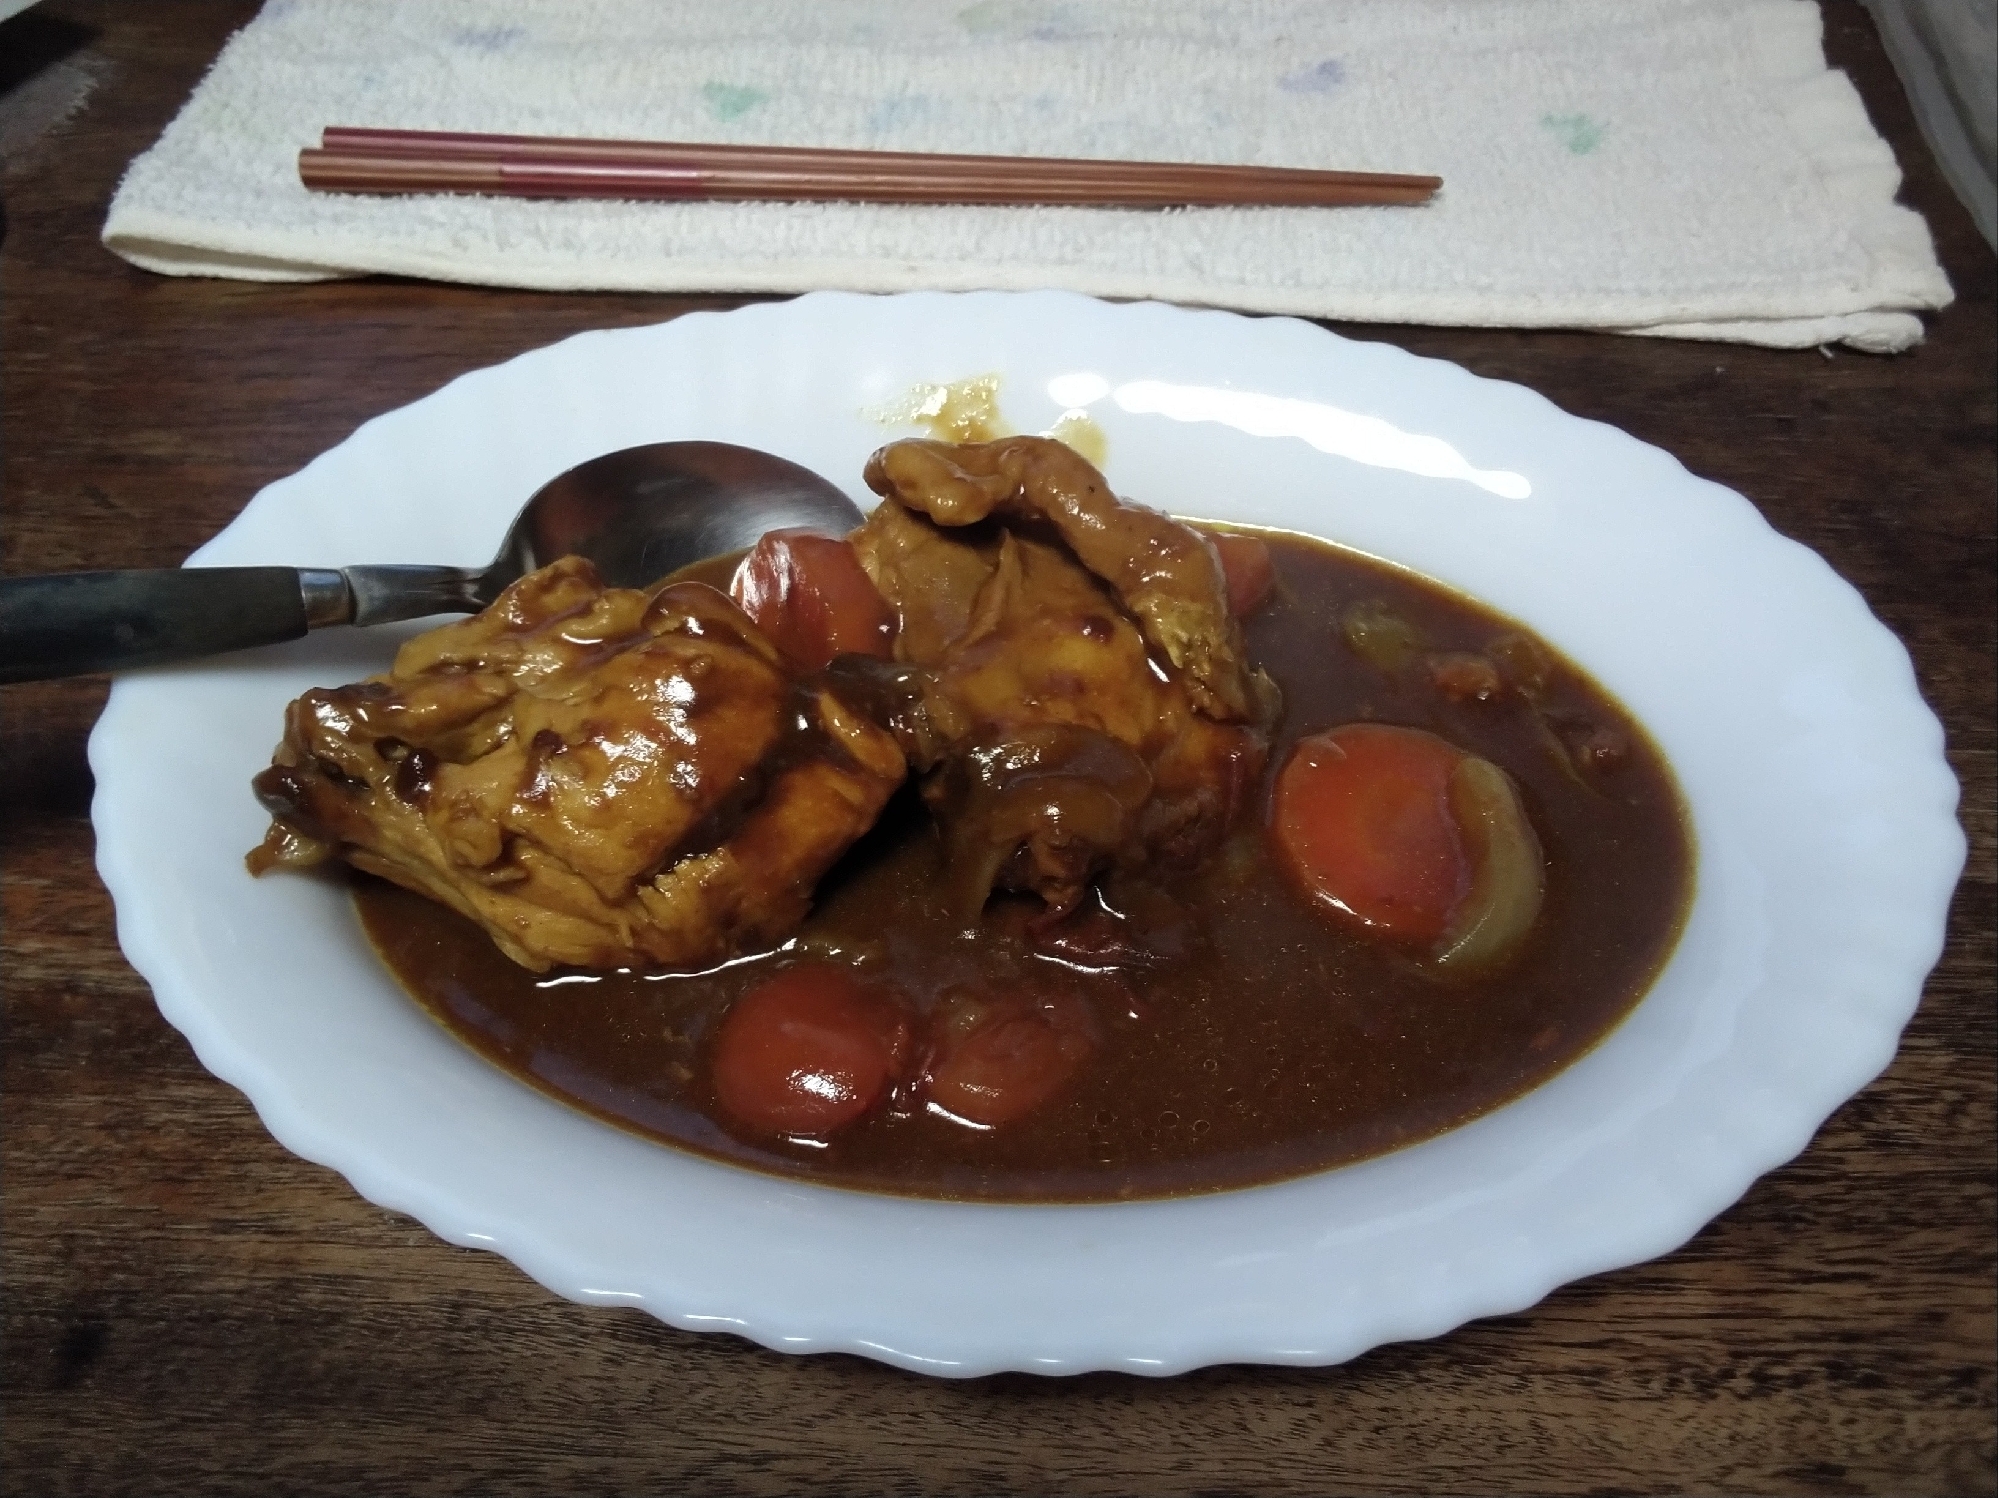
[[0, 441, 861, 681]]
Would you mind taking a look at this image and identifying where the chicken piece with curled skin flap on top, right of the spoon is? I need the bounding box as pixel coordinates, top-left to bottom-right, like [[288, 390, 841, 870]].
[[845, 437, 1277, 915]]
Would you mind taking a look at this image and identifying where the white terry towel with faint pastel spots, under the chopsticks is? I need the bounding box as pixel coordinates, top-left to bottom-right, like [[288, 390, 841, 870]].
[[104, 0, 1950, 352]]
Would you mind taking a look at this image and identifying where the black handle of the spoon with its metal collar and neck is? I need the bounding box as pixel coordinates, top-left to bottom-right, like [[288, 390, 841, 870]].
[[0, 567, 484, 681]]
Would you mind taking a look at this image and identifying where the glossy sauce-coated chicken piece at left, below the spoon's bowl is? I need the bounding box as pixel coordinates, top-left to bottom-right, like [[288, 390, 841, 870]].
[[250, 557, 907, 971]]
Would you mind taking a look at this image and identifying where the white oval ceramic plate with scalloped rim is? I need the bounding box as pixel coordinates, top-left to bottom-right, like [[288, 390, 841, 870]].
[[90, 294, 1964, 1374]]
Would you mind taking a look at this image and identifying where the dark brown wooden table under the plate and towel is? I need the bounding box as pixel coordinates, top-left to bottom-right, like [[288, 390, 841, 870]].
[[0, 0, 1994, 1494]]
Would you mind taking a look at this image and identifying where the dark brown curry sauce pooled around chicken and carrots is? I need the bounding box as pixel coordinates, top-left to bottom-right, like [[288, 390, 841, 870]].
[[356, 535, 1692, 1200]]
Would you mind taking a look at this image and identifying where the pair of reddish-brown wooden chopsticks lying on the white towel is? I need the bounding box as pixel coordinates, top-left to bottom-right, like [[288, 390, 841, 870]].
[[298, 126, 1443, 208]]
